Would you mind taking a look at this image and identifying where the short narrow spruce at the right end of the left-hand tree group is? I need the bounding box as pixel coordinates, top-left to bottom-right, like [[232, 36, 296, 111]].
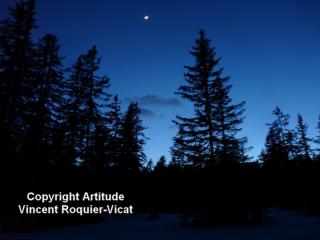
[[119, 103, 146, 174]]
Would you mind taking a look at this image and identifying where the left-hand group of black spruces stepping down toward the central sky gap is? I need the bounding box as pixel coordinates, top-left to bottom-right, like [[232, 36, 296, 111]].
[[0, 0, 146, 229]]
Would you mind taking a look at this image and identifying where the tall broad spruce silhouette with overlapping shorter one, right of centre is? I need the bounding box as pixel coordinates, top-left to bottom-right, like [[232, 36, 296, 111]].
[[174, 30, 246, 166]]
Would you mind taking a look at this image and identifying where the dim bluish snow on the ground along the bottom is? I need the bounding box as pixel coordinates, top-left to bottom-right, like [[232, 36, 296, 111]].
[[0, 209, 320, 240]]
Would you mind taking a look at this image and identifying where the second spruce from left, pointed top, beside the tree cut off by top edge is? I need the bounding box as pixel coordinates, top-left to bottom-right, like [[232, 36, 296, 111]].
[[28, 34, 64, 165]]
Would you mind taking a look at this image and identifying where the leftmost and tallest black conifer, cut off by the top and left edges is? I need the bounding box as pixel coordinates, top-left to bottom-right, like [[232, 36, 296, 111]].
[[0, 0, 36, 219]]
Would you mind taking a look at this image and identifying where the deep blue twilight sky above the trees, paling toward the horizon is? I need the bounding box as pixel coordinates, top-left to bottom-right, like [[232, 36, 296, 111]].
[[0, 0, 320, 160]]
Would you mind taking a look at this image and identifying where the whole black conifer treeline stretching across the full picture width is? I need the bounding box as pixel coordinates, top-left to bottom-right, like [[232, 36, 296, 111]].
[[0, 0, 320, 232]]
